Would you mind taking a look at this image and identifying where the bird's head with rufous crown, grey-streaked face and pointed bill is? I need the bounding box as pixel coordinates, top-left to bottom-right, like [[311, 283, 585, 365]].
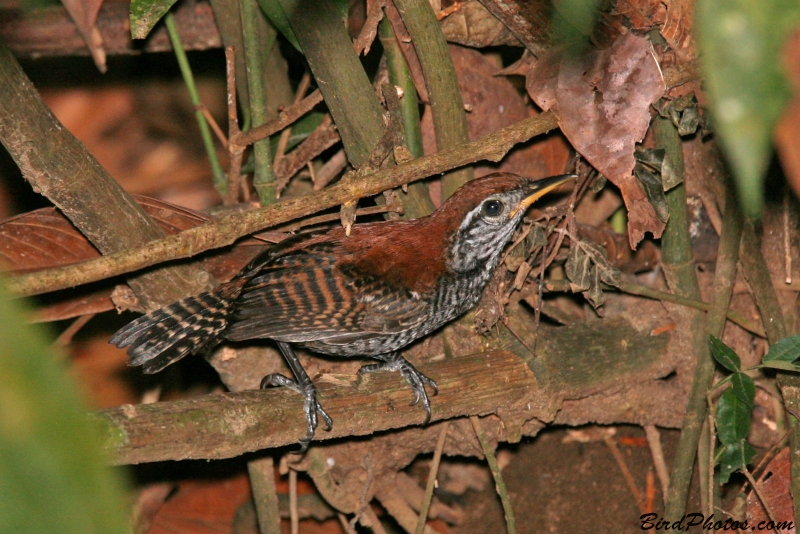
[[432, 173, 575, 272]]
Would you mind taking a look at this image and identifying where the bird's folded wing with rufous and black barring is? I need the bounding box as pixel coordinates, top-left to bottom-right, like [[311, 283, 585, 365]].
[[225, 243, 429, 344]]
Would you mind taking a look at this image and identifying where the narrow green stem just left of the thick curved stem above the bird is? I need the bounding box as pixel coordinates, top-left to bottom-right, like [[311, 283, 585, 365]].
[[378, 17, 436, 219]]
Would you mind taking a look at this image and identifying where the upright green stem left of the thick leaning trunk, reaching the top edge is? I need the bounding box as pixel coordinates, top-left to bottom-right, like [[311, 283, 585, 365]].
[[239, 0, 277, 206]]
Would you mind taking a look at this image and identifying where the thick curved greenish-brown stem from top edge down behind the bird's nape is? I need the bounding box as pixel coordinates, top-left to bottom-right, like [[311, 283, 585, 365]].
[[394, 0, 472, 199]]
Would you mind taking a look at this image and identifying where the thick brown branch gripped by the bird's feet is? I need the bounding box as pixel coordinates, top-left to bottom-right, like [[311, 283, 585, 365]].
[[91, 351, 539, 464]]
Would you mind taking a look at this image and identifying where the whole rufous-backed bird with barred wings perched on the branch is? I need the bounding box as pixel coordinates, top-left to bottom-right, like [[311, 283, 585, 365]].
[[109, 172, 575, 452]]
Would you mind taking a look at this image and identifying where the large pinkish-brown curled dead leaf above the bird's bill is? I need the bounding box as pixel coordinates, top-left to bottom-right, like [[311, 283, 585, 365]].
[[527, 34, 665, 248]]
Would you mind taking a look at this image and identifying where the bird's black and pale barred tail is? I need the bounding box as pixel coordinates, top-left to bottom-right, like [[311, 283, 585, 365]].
[[109, 282, 241, 374]]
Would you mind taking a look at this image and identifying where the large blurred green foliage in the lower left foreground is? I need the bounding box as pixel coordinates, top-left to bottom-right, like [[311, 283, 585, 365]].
[[0, 282, 129, 534]]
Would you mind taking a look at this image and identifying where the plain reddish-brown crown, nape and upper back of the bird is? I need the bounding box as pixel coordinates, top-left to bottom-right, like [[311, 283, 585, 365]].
[[334, 173, 530, 294]]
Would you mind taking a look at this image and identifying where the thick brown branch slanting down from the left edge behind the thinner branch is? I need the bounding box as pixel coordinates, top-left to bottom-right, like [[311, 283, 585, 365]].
[[0, 44, 208, 309]]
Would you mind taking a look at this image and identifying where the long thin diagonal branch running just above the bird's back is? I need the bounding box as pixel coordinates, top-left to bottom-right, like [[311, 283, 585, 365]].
[[6, 112, 558, 296]]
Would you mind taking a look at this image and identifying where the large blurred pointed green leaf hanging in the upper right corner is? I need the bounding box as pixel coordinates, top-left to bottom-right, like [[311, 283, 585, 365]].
[[695, 0, 800, 218]]
